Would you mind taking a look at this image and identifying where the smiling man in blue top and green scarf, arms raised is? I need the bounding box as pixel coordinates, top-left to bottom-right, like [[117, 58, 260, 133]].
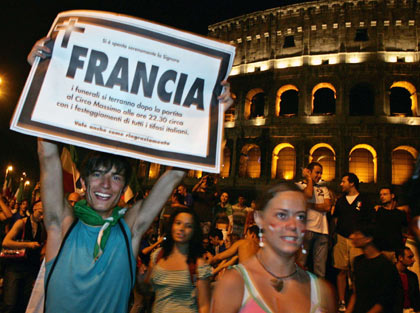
[[28, 35, 233, 313]]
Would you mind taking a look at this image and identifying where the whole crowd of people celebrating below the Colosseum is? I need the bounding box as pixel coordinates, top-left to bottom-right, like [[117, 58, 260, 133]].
[[0, 157, 420, 313]]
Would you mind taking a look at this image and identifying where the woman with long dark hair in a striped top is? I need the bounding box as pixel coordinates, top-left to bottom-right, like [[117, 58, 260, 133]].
[[149, 208, 211, 313]]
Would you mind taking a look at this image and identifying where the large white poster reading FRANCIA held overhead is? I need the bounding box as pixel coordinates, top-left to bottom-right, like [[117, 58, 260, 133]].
[[11, 11, 235, 173]]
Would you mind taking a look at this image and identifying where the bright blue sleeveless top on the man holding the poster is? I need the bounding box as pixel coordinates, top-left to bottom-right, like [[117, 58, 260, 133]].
[[45, 219, 135, 313]]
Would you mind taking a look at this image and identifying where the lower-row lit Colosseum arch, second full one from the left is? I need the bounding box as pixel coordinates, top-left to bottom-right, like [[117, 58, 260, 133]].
[[271, 143, 296, 180]]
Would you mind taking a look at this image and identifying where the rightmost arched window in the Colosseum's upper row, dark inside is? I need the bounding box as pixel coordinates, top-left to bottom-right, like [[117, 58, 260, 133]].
[[389, 81, 417, 116]]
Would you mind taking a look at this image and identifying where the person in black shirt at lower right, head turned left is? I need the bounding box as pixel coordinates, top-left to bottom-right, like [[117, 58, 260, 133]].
[[346, 225, 402, 313]]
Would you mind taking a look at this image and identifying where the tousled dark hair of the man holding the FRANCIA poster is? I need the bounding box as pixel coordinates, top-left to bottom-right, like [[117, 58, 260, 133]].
[[81, 151, 131, 187]]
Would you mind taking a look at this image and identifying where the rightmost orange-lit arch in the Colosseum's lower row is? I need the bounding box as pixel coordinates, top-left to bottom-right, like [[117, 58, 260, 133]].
[[392, 146, 418, 185]]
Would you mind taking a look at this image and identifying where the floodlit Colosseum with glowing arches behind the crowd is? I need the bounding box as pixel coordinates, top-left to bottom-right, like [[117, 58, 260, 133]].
[[144, 0, 420, 199]]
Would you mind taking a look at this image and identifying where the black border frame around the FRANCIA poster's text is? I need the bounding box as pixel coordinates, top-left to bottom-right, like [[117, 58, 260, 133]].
[[16, 14, 230, 167]]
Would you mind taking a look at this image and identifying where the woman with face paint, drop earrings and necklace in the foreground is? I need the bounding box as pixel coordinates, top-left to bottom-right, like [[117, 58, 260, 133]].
[[211, 184, 336, 313]]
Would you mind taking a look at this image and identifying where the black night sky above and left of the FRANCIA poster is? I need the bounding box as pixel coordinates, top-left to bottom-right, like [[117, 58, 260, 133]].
[[0, 0, 309, 183]]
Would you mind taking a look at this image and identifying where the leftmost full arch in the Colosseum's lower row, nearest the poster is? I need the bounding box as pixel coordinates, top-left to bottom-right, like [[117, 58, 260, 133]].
[[239, 144, 261, 178]]
